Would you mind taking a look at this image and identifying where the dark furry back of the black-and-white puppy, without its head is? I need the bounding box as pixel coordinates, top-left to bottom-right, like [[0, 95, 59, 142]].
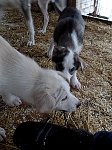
[[54, 7, 85, 49]]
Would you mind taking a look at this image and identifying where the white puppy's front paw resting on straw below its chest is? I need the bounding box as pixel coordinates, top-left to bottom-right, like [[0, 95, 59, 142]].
[[2, 94, 22, 107]]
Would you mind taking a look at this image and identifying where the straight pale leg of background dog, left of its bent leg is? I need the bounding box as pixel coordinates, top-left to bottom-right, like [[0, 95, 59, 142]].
[[21, 0, 35, 46]]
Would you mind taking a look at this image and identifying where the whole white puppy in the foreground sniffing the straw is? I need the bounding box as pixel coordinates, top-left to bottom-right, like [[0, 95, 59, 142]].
[[0, 36, 80, 140]]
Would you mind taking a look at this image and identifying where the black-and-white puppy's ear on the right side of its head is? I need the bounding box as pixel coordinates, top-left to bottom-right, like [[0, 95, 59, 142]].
[[74, 54, 86, 71]]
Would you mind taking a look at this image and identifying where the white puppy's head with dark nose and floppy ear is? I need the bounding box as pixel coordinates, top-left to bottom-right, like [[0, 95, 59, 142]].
[[33, 70, 80, 113]]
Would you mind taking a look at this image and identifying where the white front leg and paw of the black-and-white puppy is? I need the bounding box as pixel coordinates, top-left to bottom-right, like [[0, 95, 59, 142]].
[[70, 71, 81, 90]]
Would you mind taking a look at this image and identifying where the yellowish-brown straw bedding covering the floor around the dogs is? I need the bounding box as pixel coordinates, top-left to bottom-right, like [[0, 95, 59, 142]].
[[0, 9, 112, 150]]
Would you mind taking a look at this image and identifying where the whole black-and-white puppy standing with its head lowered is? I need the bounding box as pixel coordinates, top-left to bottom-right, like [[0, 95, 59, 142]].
[[48, 7, 85, 89]]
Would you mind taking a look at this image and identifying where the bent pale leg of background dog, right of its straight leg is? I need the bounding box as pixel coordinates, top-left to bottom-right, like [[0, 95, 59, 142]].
[[38, 0, 50, 33]]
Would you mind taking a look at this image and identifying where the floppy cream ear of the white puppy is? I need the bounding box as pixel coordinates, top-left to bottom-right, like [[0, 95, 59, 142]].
[[34, 90, 56, 113]]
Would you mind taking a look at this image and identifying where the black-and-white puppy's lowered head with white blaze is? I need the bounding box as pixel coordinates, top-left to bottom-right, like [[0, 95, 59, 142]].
[[52, 47, 85, 80]]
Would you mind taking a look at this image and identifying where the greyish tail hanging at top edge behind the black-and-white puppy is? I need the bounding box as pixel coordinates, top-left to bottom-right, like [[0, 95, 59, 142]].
[[51, 0, 67, 15]]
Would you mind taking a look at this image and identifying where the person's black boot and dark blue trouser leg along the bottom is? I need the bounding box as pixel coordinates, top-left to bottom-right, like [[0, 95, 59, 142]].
[[13, 122, 112, 150]]
